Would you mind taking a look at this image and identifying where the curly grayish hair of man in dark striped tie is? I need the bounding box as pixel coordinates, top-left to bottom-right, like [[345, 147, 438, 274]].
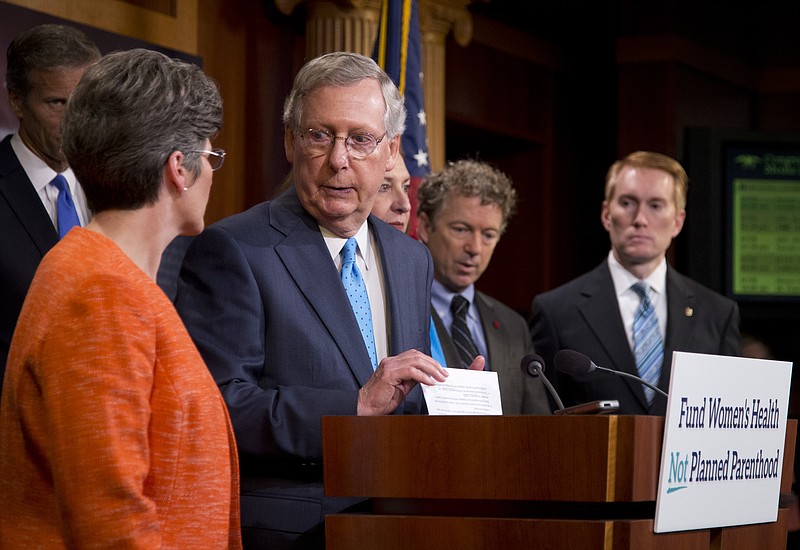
[[417, 159, 517, 233]]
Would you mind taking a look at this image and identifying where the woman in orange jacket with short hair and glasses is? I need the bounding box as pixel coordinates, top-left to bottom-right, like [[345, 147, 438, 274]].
[[0, 50, 241, 548]]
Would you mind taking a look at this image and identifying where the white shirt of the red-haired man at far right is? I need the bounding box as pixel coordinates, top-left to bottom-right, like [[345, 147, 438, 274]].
[[608, 252, 667, 348]]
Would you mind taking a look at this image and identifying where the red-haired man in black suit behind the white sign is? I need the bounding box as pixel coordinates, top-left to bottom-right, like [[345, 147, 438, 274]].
[[531, 151, 739, 415]]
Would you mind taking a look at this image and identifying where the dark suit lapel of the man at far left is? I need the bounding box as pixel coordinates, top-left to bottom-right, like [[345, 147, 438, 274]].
[[0, 136, 58, 256]]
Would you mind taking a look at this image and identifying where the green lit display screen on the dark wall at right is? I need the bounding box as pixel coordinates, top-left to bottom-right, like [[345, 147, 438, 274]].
[[728, 150, 800, 299]]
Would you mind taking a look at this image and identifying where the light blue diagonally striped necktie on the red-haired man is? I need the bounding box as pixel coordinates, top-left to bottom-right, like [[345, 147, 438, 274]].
[[631, 282, 664, 403]]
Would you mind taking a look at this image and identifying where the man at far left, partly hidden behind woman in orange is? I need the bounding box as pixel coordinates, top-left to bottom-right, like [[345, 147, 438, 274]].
[[0, 24, 100, 385]]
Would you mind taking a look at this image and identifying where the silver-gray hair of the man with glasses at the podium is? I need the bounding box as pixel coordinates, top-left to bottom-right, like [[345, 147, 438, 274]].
[[283, 52, 406, 139]]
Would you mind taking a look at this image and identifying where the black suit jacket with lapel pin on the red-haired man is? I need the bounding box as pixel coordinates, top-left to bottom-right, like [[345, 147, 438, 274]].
[[531, 260, 739, 415]]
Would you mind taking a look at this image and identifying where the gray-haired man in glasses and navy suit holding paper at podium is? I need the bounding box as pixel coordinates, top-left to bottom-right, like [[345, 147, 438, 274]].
[[176, 52, 483, 549]]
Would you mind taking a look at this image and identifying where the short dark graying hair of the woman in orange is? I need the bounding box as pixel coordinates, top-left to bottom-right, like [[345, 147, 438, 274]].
[[61, 49, 222, 212]]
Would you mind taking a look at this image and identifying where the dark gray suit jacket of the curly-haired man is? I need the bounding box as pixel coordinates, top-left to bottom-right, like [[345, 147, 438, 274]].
[[431, 291, 552, 414]]
